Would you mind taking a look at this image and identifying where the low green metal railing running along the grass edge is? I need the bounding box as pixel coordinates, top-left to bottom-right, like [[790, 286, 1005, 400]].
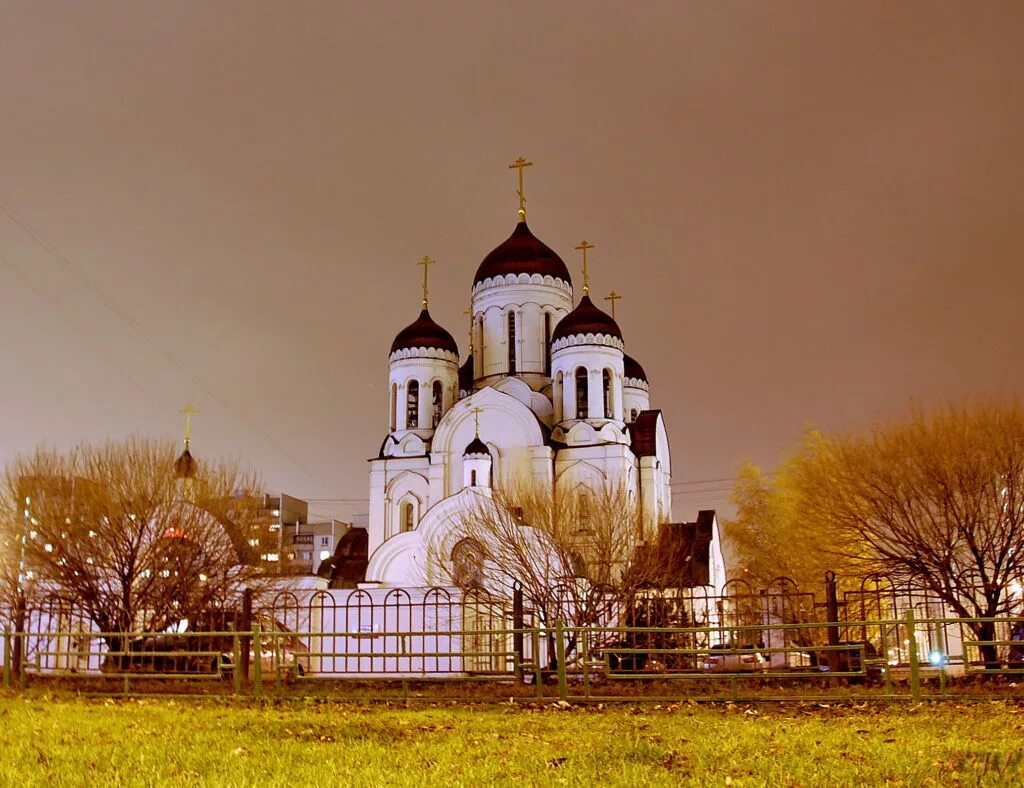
[[3, 609, 1024, 701]]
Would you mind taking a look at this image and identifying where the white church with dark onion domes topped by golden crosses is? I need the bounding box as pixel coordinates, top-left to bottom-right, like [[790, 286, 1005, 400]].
[[362, 169, 725, 588]]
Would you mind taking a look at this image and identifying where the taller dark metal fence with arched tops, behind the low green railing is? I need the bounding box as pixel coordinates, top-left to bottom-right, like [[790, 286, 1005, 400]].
[[3, 578, 1024, 700]]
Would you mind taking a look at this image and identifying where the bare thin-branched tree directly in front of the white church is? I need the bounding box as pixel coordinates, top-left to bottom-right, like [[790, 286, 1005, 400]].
[[428, 484, 666, 664]]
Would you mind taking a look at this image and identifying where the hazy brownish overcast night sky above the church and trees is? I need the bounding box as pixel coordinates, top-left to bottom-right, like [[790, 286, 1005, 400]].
[[0, 0, 1024, 517]]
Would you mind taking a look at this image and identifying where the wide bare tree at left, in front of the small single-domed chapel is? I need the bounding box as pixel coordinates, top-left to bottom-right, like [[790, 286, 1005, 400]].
[[0, 439, 265, 650]]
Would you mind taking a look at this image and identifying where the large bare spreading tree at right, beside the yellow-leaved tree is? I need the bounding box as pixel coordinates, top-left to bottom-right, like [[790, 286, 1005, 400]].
[[794, 401, 1024, 664]]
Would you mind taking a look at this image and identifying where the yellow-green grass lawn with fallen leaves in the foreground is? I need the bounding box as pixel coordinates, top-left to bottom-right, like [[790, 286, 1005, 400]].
[[0, 694, 1024, 786]]
